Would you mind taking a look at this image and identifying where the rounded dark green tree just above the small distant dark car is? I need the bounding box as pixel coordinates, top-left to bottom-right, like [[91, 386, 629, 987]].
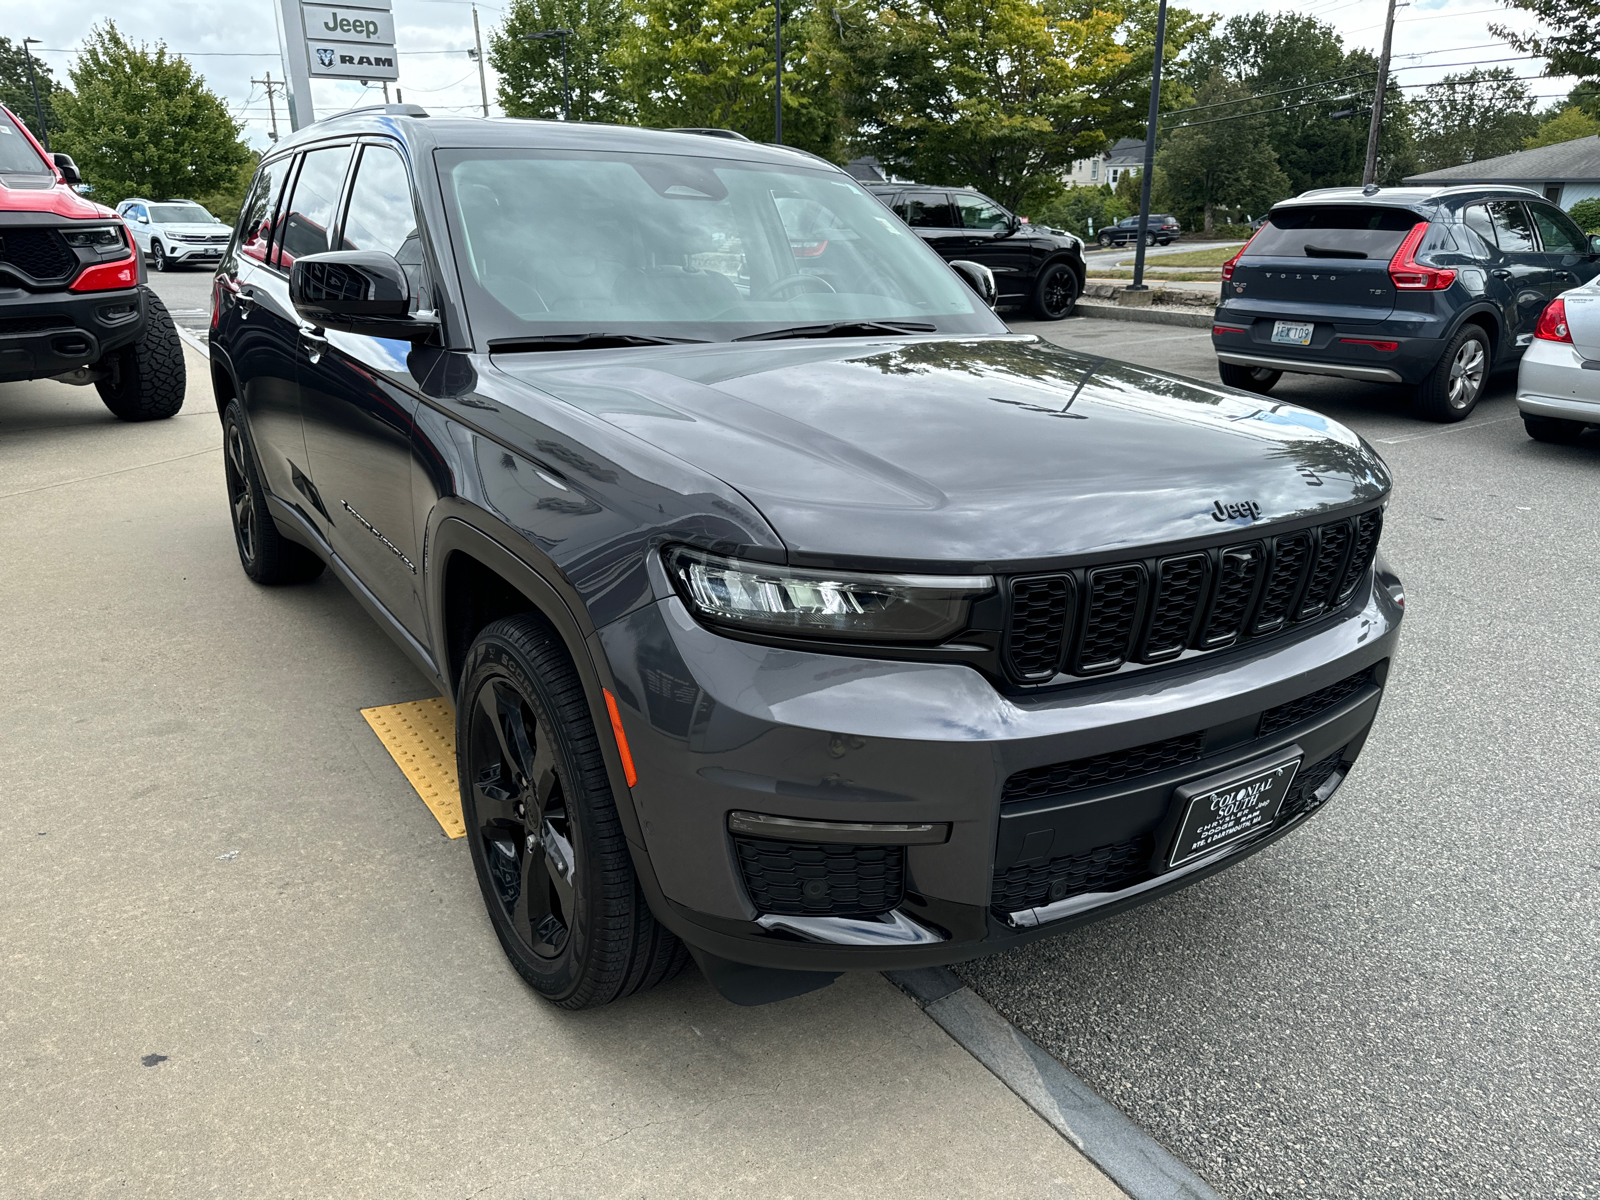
[[1155, 69, 1290, 234]]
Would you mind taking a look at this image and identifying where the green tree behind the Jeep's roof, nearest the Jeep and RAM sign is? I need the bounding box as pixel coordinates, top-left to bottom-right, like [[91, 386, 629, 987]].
[[488, 0, 634, 122]]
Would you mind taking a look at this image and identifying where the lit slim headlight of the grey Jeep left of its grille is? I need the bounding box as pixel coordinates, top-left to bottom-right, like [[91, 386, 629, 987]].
[[666, 546, 995, 642]]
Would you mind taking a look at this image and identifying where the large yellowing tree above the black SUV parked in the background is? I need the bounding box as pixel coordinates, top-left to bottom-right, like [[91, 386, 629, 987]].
[[816, 0, 1210, 208]]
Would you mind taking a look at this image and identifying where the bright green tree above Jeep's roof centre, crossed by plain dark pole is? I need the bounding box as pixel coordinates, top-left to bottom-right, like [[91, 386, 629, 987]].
[[616, 0, 837, 157]]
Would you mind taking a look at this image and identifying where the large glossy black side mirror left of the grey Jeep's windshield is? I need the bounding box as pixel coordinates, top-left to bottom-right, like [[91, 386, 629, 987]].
[[290, 250, 438, 342]]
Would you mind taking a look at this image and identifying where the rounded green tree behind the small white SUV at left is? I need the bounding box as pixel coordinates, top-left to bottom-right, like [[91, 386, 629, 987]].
[[56, 21, 250, 205]]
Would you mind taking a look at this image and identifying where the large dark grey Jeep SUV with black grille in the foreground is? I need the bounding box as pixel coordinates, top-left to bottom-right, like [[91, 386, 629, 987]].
[[211, 106, 1402, 1008]]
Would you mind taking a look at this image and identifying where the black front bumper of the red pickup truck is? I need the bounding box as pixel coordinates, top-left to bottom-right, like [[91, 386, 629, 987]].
[[0, 288, 146, 382]]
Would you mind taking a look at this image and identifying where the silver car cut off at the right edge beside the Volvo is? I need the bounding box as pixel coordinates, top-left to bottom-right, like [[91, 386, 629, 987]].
[[1517, 277, 1600, 443]]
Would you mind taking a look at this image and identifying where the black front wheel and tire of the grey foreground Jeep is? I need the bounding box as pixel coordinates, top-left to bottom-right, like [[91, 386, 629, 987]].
[[456, 614, 688, 1008]]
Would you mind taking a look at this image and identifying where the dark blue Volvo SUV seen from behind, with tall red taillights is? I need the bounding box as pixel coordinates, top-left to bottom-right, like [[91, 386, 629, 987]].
[[1211, 186, 1600, 421]]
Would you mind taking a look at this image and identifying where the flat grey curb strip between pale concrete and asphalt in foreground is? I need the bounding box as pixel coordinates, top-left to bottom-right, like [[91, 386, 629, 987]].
[[883, 966, 1221, 1200]]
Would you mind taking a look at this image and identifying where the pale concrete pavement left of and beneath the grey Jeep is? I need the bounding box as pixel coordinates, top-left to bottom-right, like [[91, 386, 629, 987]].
[[0, 352, 1120, 1200]]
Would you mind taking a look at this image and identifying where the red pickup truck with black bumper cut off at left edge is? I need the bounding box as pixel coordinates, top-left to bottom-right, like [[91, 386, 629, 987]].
[[0, 106, 184, 421]]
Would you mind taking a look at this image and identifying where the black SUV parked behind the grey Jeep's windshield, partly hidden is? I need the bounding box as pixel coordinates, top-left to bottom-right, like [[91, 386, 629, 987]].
[[867, 184, 1085, 322]]
